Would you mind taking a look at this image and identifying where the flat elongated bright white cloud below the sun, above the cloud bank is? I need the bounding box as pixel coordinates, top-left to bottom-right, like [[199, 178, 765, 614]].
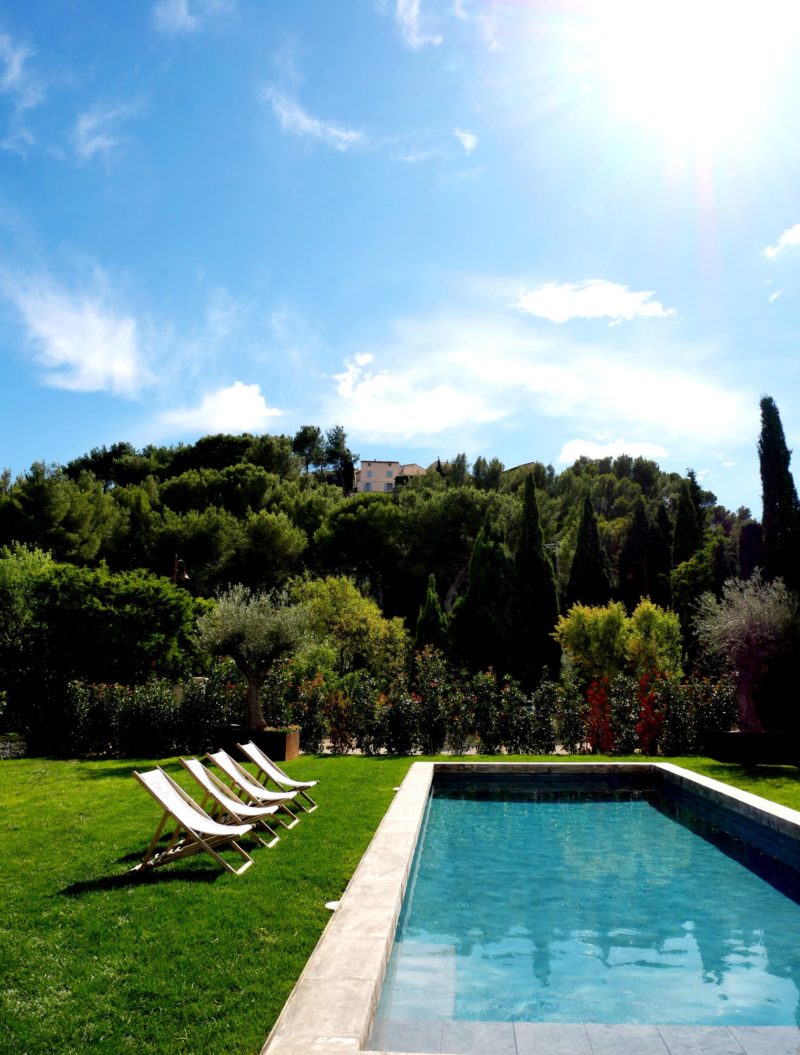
[[514, 279, 675, 326]]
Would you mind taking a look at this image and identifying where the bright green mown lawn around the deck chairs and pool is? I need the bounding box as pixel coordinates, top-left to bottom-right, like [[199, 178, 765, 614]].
[[0, 756, 800, 1055]]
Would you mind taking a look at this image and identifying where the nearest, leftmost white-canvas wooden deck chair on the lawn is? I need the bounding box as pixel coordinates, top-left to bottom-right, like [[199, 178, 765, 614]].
[[131, 769, 253, 876]]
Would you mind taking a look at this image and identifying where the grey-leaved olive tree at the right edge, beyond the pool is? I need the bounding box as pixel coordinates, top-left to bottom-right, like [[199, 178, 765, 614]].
[[694, 569, 797, 732]]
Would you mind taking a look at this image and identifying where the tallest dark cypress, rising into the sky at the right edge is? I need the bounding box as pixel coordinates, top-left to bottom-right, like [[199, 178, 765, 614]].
[[759, 396, 800, 589]]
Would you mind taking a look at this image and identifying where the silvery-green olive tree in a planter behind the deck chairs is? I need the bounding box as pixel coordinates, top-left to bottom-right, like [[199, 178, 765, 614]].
[[197, 583, 309, 729]]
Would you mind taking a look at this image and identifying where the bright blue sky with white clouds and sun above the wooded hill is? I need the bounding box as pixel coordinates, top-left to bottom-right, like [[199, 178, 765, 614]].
[[0, 0, 800, 515]]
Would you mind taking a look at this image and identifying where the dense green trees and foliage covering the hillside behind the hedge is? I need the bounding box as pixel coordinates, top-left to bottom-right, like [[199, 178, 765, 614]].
[[0, 399, 797, 750]]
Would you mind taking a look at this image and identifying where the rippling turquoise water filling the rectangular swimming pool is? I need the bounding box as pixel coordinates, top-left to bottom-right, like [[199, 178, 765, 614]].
[[376, 792, 800, 1025]]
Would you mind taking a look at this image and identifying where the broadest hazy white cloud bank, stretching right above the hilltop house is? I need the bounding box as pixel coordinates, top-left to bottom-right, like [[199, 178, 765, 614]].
[[324, 314, 757, 449]]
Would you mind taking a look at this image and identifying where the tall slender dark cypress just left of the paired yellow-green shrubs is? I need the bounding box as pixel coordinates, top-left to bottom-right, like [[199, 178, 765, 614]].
[[513, 474, 560, 689]]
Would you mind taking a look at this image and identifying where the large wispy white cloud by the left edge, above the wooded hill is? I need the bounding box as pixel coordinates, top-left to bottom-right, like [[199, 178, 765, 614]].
[[4, 277, 151, 396]]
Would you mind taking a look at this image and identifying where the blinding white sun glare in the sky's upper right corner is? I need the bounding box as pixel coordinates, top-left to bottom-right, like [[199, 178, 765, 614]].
[[588, 0, 800, 154]]
